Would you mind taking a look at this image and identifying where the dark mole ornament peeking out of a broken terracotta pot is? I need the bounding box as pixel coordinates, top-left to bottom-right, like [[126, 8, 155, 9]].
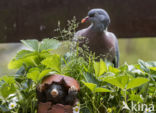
[[37, 74, 80, 113]]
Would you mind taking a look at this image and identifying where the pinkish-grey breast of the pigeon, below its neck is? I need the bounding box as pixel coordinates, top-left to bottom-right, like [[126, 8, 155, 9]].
[[83, 32, 115, 61]]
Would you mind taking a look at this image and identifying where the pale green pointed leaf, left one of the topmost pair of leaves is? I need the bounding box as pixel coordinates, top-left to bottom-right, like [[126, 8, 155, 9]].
[[21, 39, 39, 51]]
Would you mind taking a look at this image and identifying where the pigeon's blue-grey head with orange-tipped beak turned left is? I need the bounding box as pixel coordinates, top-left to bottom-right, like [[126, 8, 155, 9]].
[[81, 9, 110, 29]]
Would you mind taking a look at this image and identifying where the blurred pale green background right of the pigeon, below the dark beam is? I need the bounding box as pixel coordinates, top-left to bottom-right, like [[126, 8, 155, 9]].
[[119, 37, 156, 64]]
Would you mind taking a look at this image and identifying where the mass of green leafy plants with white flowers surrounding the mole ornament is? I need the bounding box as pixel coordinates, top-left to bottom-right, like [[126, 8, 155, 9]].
[[0, 20, 156, 113]]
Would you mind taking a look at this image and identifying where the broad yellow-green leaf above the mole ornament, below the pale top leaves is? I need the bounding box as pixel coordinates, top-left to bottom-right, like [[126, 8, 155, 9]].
[[41, 54, 61, 72]]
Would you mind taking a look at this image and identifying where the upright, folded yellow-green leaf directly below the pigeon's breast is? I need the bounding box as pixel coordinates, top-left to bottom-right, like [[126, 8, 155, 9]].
[[94, 59, 107, 77]]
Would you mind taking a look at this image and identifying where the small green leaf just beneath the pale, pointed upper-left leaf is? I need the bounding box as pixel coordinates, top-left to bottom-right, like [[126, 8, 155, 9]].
[[16, 50, 33, 59]]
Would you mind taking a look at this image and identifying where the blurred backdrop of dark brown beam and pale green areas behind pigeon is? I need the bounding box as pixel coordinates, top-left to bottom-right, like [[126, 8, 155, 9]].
[[0, 0, 156, 75]]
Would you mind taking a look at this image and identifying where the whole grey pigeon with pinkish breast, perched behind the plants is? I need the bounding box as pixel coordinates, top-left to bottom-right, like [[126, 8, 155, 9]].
[[74, 9, 119, 67]]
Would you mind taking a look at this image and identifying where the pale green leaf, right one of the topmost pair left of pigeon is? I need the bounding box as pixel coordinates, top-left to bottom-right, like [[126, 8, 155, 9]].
[[40, 39, 61, 51]]
